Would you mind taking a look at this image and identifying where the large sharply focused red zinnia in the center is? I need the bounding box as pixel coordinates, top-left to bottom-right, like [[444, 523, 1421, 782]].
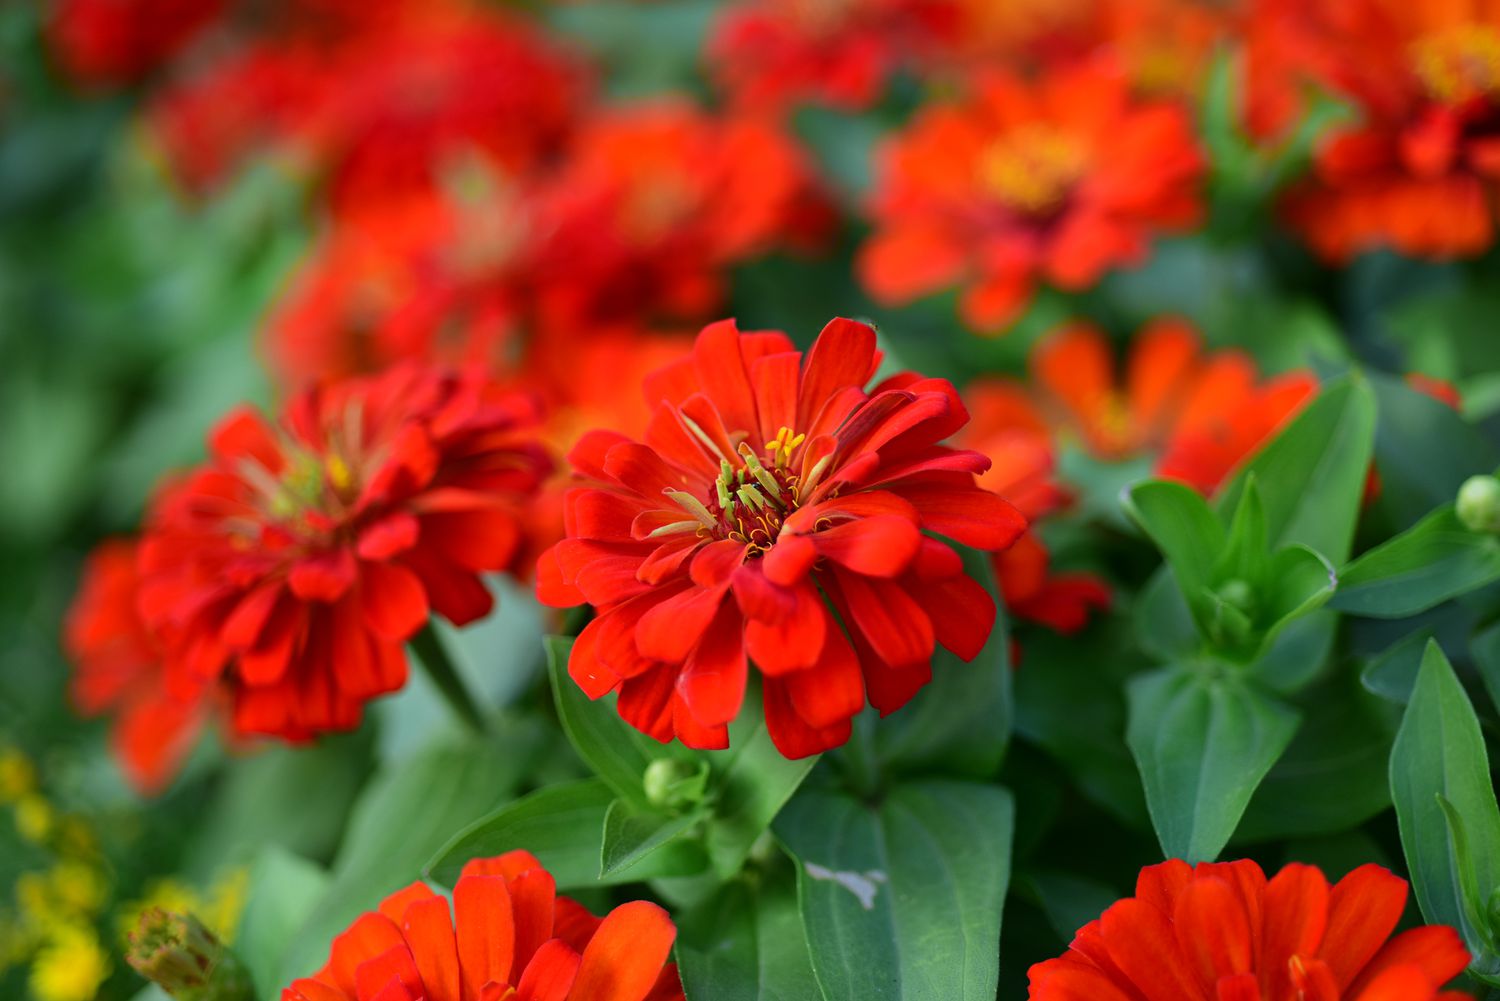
[[539, 320, 1026, 758]]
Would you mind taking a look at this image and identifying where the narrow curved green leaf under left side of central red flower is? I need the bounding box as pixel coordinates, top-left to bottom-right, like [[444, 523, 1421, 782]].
[[546, 636, 693, 810]]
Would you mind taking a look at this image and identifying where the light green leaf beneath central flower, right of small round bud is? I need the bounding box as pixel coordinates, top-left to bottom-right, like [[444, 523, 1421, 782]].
[[705, 708, 818, 878]]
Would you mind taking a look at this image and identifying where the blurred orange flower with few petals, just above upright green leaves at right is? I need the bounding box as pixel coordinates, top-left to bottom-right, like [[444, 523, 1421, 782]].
[[1031, 320, 1317, 494]]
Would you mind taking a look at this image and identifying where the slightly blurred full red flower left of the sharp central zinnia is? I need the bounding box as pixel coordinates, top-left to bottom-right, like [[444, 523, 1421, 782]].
[[141, 366, 548, 740]]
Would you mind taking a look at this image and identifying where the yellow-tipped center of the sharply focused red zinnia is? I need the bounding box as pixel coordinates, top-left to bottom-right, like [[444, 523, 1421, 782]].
[[705, 428, 807, 555]]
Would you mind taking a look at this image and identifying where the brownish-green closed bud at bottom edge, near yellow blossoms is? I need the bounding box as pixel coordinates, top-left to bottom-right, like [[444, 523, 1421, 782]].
[[125, 908, 255, 1001]]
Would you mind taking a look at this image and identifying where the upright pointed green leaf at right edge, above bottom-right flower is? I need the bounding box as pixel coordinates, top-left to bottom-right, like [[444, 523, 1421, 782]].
[[1391, 642, 1500, 974]]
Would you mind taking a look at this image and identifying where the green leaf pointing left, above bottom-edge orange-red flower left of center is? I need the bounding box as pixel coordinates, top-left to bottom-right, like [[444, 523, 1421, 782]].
[[425, 779, 704, 888]]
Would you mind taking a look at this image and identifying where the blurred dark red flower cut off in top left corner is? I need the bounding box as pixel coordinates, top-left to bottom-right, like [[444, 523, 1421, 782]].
[[47, 0, 225, 89]]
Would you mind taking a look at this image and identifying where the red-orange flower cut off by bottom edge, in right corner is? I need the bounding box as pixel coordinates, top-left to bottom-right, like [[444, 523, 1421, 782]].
[[1031, 861, 1469, 1001]]
